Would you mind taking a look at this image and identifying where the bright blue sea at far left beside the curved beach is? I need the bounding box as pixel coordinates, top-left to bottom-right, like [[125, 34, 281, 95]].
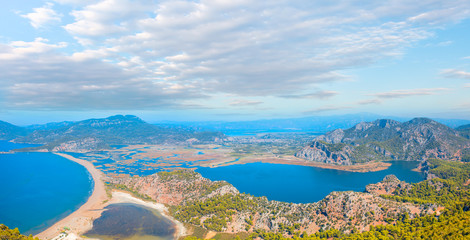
[[0, 141, 93, 234]]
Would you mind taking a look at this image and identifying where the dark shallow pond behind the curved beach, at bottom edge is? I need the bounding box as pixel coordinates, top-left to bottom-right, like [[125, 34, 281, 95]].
[[84, 203, 175, 240]]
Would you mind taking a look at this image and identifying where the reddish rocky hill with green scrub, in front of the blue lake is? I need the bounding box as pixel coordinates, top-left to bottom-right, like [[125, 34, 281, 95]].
[[110, 170, 437, 234]]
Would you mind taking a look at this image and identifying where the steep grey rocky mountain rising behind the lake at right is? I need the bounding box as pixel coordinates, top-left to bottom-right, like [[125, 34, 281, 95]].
[[295, 118, 470, 165]]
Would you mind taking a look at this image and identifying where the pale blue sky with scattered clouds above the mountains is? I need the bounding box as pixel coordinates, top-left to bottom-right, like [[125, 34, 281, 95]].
[[0, 0, 470, 125]]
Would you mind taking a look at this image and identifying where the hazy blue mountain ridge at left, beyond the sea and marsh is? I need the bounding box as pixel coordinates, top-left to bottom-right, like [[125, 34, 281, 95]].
[[0, 115, 226, 151]]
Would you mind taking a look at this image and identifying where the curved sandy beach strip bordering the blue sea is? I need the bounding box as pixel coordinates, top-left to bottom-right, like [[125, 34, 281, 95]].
[[35, 153, 109, 239]]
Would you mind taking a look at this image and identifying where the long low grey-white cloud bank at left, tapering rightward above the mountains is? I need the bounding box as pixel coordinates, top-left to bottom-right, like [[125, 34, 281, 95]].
[[0, 38, 205, 110]]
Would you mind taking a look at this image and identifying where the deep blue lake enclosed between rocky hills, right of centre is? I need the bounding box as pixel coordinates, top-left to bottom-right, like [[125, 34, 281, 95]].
[[196, 161, 424, 203]]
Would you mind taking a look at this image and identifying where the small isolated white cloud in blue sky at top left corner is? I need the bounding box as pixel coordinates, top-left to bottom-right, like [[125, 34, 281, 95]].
[[21, 3, 63, 28]]
